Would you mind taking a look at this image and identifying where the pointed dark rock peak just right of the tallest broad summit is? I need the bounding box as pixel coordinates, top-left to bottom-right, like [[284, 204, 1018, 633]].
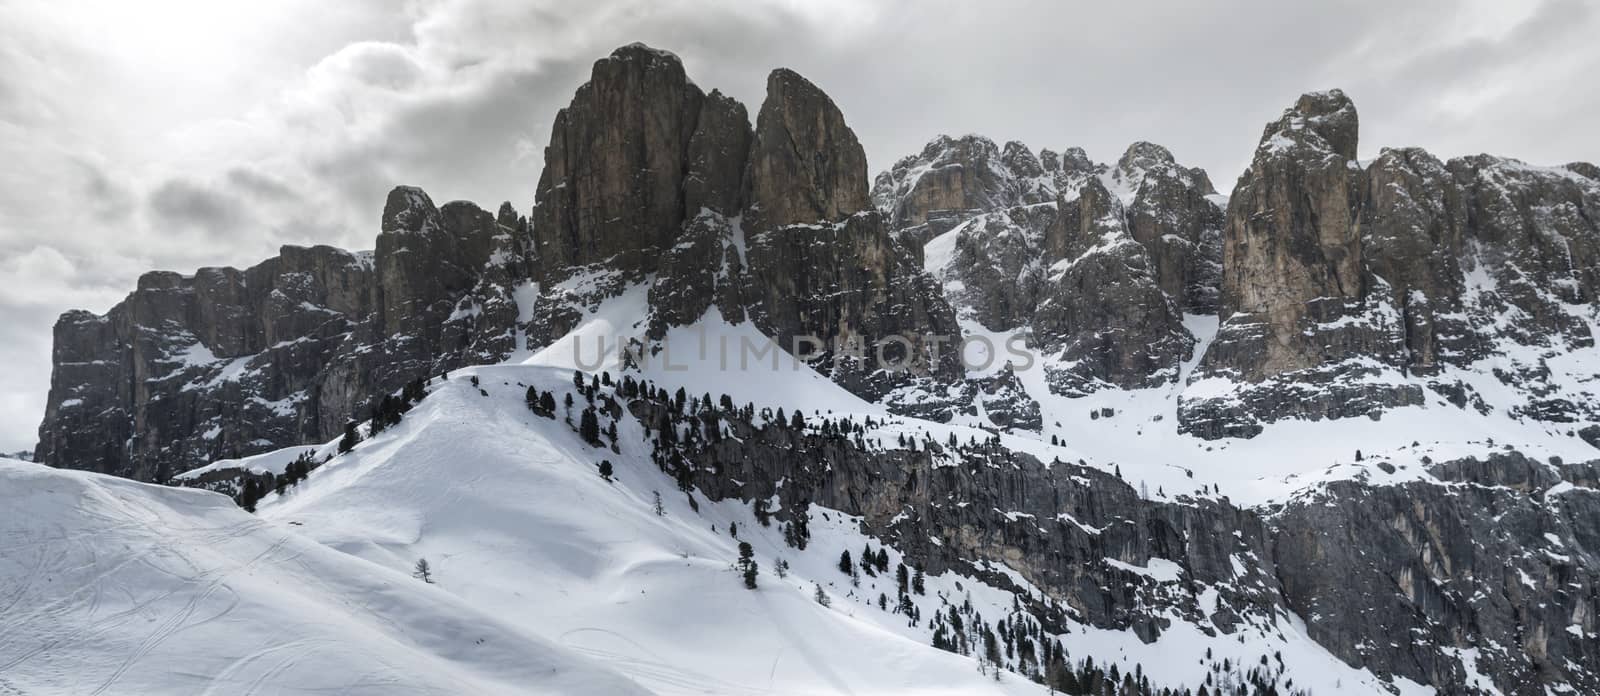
[[746, 67, 870, 230]]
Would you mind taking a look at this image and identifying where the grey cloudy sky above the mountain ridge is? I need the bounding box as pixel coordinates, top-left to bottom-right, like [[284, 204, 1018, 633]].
[[0, 0, 1600, 451]]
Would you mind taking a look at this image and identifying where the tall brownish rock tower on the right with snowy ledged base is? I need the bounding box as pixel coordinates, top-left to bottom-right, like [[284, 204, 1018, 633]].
[[1179, 90, 1422, 437]]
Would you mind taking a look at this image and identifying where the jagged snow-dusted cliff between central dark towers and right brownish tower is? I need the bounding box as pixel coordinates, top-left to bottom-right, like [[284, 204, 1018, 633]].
[[874, 136, 1222, 395]]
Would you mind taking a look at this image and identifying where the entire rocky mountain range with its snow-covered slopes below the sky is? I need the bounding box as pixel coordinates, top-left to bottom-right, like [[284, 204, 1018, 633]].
[[12, 45, 1600, 694]]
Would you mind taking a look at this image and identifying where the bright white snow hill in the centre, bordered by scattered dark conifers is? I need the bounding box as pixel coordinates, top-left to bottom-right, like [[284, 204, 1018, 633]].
[[261, 366, 1042, 694]]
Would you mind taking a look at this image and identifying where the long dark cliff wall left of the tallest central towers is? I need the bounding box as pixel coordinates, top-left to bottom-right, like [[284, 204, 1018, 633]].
[[38, 187, 526, 482]]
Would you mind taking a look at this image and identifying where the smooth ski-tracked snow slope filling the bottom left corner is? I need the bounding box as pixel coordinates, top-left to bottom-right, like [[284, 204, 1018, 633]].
[[0, 459, 645, 696]]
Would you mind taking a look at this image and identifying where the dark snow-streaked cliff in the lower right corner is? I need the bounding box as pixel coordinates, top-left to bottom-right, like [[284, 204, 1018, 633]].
[[1269, 453, 1600, 693]]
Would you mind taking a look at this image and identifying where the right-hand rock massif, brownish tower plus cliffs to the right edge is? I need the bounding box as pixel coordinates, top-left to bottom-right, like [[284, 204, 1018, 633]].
[[1179, 91, 1600, 438]]
